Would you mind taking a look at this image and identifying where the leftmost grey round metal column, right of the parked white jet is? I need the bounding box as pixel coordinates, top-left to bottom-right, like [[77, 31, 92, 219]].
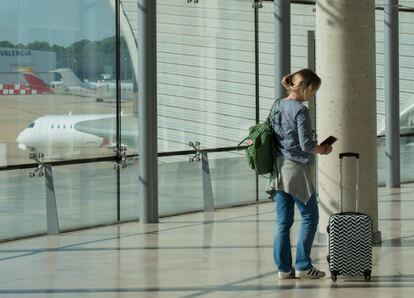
[[138, 0, 158, 223]]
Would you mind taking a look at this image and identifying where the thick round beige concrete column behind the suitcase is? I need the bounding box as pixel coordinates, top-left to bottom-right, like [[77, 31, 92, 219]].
[[316, 0, 379, 241]]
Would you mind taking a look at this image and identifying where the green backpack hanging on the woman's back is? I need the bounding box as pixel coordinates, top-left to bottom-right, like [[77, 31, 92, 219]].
[[237, 99, 279, 175]]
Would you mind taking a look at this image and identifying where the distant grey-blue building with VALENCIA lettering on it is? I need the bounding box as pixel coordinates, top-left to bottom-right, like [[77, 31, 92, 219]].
[[0, 48, 56, 84]]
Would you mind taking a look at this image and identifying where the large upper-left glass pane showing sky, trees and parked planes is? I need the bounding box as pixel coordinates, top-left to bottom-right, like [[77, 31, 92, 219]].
[[0, 0, 115, 165]]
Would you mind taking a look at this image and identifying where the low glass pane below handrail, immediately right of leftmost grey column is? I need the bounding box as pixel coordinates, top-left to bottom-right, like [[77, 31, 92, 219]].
[[158, 155, 204, 215]]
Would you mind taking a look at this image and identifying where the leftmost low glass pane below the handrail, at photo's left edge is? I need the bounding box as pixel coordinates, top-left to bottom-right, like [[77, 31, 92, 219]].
[[0, 169, 47, 240]]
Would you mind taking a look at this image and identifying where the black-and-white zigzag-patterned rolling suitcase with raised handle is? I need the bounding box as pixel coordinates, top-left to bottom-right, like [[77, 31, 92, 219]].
[[327, 152, 372, 282]]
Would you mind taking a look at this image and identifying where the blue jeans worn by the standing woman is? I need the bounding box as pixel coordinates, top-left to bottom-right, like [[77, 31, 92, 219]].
[[273, 191, 319, 272]]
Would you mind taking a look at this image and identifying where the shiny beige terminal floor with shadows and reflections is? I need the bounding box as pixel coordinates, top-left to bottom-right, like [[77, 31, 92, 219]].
[[0, 184, 414, 298]]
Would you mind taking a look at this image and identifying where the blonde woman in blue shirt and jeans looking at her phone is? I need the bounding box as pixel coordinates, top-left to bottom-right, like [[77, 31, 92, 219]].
[[272, 69, 332, 279]]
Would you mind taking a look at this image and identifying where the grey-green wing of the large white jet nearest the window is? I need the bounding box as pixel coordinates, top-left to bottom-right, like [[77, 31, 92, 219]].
[[75, 116, 138, 148]]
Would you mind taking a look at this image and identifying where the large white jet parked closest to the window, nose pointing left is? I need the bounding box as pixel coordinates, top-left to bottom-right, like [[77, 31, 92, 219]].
[[16, 114, 138, 159]]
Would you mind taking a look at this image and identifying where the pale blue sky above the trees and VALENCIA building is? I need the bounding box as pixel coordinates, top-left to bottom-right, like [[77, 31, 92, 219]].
[[0, 0, 115, 47]]
